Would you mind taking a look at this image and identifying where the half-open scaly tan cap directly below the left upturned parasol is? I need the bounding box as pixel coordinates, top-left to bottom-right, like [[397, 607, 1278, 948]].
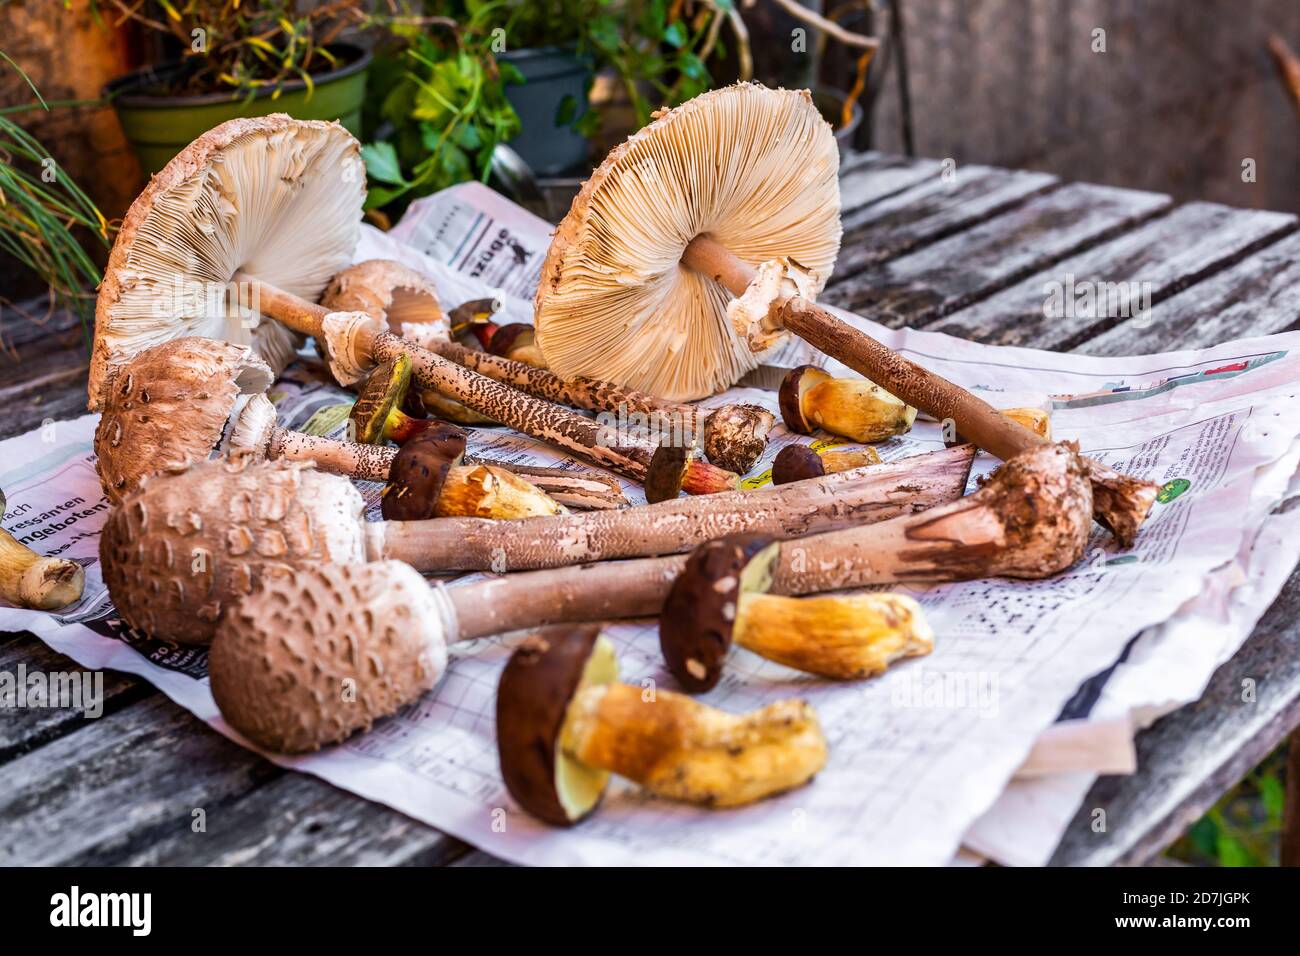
[[95, 336, 274, 505]]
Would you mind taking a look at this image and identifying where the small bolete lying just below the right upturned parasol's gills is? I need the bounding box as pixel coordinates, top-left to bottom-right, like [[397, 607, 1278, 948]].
[[780, 365, 917, 444]]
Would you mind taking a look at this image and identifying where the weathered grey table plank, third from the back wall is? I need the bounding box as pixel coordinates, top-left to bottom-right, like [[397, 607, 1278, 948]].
[[820, 183, 1169, 326]]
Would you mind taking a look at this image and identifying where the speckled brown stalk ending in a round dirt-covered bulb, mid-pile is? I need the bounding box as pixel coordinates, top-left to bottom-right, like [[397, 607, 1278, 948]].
[[430, 338, 776, 475]]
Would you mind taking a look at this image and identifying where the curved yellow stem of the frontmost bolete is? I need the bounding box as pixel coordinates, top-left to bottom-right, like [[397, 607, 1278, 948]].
[[559, 684, 827, 806]]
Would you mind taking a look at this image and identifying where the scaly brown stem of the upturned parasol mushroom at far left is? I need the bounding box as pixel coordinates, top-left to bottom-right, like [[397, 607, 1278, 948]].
[[234, 273, 691, 483]]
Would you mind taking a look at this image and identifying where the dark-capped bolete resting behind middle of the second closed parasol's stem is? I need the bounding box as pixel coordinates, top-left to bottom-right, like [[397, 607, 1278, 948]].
[[380, 423, 568, 522]]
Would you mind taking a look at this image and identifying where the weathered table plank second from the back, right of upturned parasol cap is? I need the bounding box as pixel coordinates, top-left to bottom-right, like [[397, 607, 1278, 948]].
[[835, 166, 1057, 274]]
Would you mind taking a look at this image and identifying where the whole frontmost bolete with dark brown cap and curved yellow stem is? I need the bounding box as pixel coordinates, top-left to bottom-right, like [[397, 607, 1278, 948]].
[[497, 626, 827, 826]]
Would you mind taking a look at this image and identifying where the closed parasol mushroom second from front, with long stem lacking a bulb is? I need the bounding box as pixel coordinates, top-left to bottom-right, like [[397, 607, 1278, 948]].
[[100, 449, 974, 644]]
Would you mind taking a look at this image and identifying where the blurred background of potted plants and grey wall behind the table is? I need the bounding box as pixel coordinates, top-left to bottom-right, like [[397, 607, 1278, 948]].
[[0, 0, 1300, 865]]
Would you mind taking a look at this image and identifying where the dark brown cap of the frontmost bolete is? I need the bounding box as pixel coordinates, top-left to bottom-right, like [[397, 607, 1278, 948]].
[[497, 626, 619, 826]]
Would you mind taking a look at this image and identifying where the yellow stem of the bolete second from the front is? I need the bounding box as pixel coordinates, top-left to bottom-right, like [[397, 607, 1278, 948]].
[[732, 593, 935, 680]]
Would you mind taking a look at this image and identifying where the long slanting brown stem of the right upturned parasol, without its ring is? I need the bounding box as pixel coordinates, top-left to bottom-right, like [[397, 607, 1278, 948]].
[[681, 235, 1157, 546]]
